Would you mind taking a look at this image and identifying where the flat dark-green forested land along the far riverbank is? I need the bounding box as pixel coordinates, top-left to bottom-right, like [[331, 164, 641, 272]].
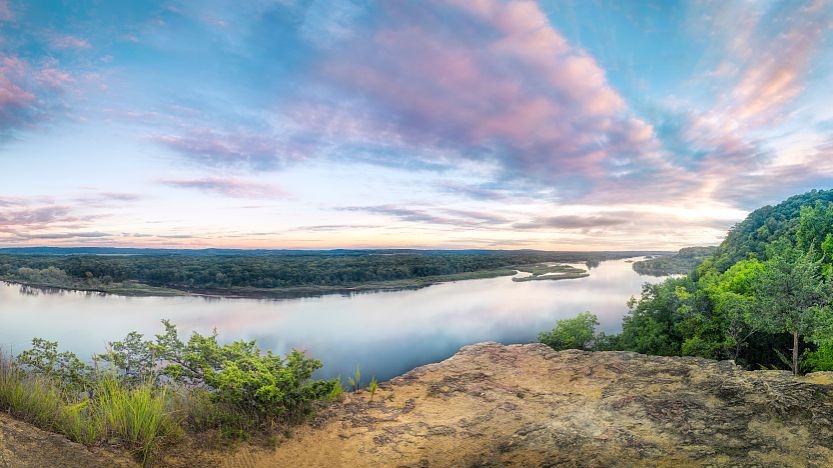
[[0, 248, 668, 298]]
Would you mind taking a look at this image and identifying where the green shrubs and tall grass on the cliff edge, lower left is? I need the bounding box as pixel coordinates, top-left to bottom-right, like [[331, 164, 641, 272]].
[[0, 321, 341, 464]]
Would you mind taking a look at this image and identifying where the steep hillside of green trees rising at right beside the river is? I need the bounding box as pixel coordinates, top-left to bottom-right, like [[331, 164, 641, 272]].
[[603, 190, 833, 372]]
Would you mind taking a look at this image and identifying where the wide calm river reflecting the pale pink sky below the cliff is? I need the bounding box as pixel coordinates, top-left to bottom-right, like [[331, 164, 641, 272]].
[[0, 260, 661, 380]]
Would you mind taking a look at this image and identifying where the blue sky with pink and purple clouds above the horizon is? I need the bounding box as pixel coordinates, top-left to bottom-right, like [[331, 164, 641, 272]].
[[0, 0, 833, 250]]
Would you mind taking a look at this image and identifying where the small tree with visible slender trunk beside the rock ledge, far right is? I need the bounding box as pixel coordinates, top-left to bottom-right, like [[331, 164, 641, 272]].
[[750, 243, 831, 374]]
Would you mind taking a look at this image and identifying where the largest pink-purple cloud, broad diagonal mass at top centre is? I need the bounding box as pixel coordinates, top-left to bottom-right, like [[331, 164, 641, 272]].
[[308, 0, 659, 186]]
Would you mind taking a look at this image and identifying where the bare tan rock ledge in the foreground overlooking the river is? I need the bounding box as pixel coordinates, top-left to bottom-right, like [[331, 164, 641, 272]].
[[231, 343, 833, 467]]
